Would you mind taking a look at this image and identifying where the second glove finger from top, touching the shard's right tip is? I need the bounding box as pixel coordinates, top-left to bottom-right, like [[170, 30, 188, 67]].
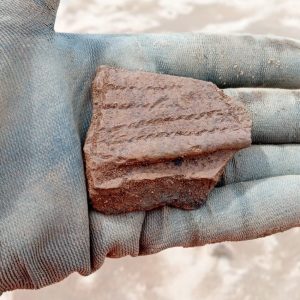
[[224, 88, 300, 144]]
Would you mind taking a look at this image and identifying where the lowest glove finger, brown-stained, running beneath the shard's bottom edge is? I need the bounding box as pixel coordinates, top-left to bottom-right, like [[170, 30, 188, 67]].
[[90, 175, 300, 269]]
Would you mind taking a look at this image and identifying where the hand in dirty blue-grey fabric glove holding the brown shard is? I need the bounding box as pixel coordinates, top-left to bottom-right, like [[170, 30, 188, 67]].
[[0, 0, 300, 292]]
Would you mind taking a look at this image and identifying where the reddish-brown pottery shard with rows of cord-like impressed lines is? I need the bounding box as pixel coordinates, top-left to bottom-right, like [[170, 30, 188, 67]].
[[84, 66, 251, 213]]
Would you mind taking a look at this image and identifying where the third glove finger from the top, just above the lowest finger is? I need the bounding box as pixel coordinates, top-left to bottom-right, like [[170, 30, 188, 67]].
[[221, 144, 300, 185]]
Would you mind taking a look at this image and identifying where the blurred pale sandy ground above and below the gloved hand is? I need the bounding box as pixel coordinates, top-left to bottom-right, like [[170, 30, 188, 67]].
[[0, 0, 300, 300]]
